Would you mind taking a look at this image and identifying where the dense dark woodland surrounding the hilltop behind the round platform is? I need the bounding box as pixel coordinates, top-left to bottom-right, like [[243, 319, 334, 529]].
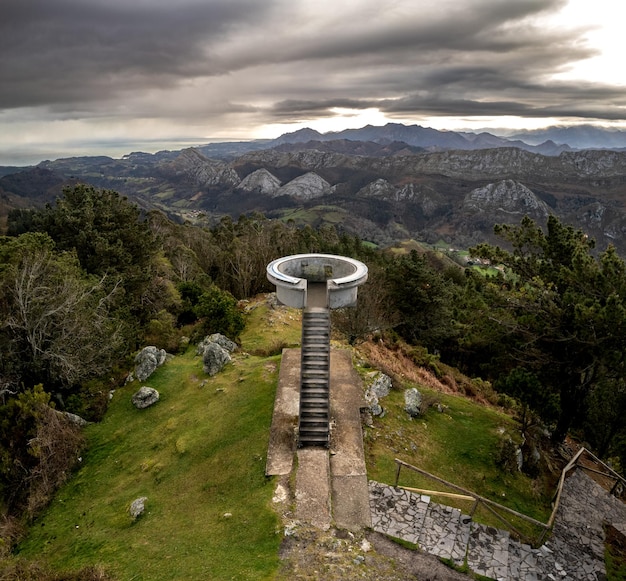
[[0, 185, 626, 544]]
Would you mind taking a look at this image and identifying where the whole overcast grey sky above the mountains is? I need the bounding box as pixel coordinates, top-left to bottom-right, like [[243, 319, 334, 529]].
[[0, 0, 626, 165]]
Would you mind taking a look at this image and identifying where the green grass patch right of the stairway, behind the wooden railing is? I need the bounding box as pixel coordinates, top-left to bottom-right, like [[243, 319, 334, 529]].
[[365, 386, 550, 535]]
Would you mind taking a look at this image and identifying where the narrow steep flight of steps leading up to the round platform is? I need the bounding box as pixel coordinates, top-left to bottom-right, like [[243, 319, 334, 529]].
[[298, 307, 330, 448]]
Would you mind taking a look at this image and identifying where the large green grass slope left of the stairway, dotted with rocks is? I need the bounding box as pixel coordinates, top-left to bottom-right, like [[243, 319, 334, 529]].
[[18, 350, 281, 581]]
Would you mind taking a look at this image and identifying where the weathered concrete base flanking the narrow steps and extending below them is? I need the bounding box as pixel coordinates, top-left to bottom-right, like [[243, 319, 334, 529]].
[[265, 349, 371, 530]]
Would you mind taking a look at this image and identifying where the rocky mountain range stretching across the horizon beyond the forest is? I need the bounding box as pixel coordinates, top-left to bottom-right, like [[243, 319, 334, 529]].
[[0, 124, 626, 255]]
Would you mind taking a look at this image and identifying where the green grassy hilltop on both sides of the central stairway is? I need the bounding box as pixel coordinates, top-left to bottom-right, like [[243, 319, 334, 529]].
[[12, 301, 545, 581]]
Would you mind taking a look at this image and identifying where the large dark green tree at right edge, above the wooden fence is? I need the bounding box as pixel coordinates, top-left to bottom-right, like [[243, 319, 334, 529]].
[[472, 217, 626, 441]]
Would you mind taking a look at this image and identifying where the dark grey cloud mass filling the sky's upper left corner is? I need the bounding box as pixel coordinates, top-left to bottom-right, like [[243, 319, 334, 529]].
[[0, 0, 271, 108]]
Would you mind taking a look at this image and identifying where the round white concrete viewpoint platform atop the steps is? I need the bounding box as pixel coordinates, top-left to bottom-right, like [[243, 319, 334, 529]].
[[267, 254, 367, 309]]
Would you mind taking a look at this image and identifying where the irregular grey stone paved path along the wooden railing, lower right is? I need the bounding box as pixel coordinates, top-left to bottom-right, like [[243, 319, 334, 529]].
[[369, 469, 626, 581]]
